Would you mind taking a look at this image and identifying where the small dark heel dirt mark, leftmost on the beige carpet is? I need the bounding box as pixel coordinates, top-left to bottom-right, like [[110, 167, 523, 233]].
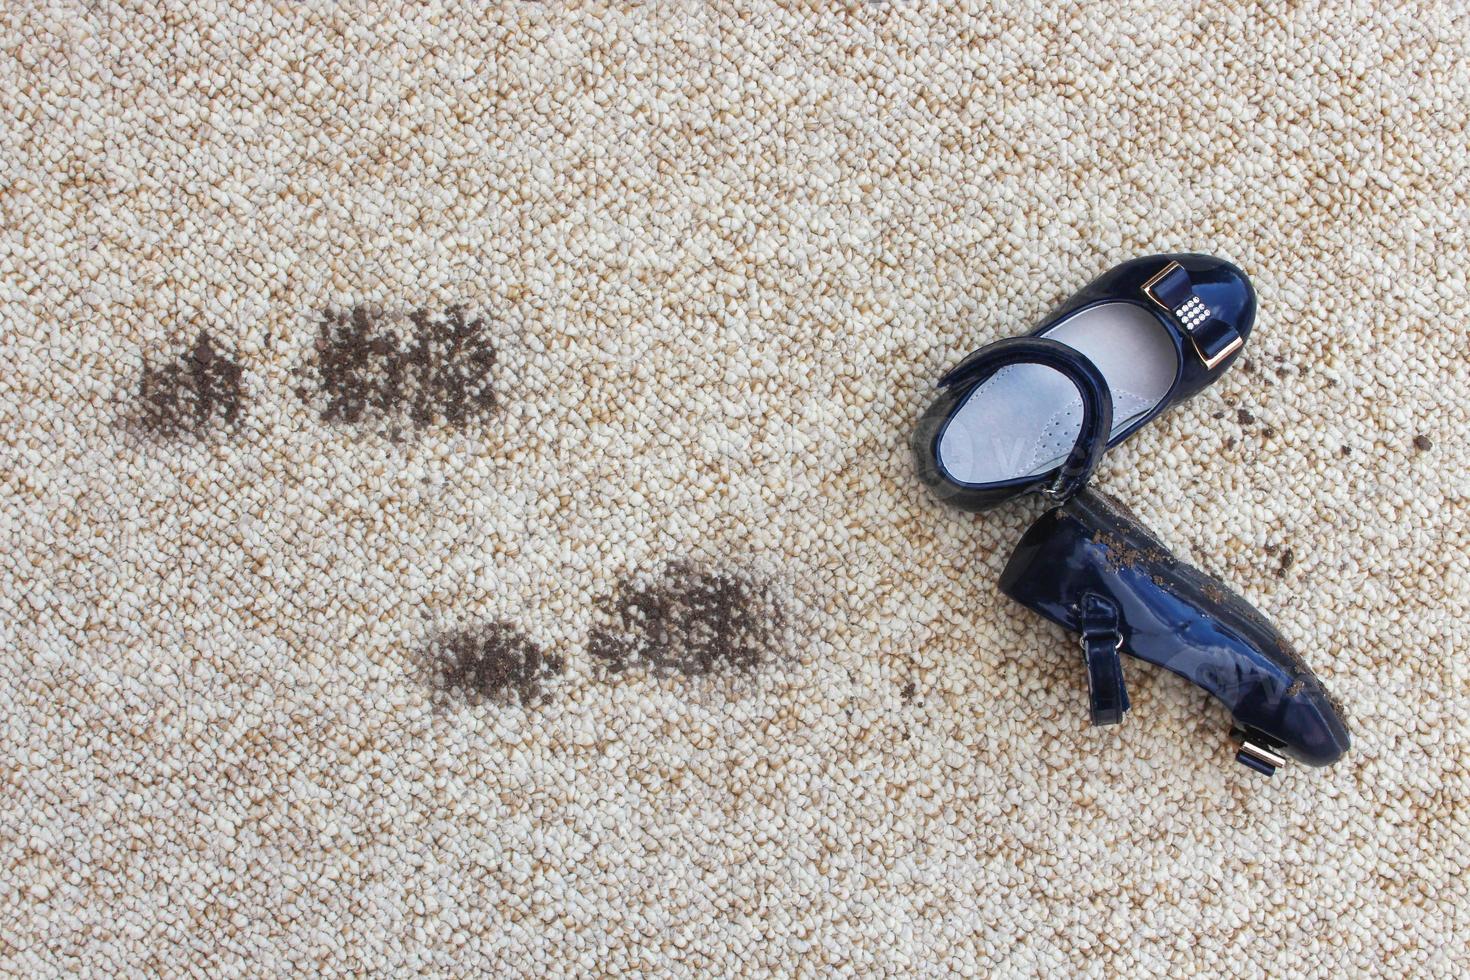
[[137, 331, 244, 438]]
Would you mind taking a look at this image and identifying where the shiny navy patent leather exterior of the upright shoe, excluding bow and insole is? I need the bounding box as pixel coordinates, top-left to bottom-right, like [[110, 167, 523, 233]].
[[911, 253, 1255, 511]]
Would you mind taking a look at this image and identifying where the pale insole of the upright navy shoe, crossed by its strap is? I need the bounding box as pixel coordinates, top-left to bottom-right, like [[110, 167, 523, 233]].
[[936, 303, 1179, 483]]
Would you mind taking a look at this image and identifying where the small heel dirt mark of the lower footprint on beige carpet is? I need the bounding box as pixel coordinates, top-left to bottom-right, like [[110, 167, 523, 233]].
[[423, 621, 566, 705]]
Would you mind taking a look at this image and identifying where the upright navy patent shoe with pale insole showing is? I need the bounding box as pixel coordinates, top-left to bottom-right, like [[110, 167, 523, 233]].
[[913, 254, 1255, 510]]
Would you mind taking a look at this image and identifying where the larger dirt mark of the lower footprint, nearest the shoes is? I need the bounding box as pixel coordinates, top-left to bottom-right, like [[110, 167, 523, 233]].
[[588, 561, 788, 676]]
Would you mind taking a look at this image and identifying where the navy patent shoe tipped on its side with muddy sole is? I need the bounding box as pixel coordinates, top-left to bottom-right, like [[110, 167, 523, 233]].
[[1000, 491, 1349, 776]]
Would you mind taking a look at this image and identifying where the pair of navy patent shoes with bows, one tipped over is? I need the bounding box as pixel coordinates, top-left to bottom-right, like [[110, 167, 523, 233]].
[[913, 254, 1349, 776]]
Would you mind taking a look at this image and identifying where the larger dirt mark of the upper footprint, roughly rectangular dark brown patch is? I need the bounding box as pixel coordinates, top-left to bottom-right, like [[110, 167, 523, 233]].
[[301, 306, 497, 429]]
